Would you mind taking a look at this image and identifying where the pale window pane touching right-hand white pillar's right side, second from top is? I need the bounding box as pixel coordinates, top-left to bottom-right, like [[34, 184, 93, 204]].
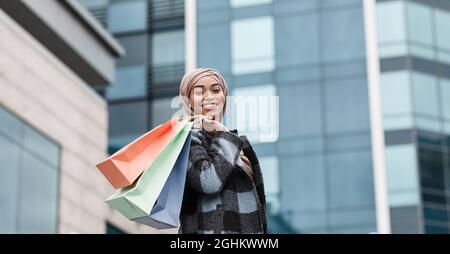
[[380, 71, 412, 115]]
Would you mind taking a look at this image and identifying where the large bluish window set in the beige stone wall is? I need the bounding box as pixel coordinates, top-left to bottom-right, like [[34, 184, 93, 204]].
[[0, 107, 60, 234]]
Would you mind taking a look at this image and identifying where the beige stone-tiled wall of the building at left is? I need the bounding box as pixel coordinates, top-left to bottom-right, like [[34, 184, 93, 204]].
[[0, 7, 167, 233]]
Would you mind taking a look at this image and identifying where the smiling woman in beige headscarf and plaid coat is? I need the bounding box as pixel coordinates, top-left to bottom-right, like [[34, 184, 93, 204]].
[[180, 68, 267, 234]]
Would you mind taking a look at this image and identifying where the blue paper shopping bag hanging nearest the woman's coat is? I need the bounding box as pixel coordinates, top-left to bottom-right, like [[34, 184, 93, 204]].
[[133, 131, 191, 229]]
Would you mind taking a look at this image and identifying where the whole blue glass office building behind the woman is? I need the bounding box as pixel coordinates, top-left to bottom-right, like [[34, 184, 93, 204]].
[[83, 0, 450, 233]]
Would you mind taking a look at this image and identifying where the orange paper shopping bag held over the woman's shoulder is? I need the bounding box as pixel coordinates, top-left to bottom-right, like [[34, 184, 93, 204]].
[[96, 118, 183, 189]]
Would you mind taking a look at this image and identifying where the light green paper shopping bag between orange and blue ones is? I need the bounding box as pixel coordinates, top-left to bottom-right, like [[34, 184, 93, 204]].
[[105, 121, 192, 220]]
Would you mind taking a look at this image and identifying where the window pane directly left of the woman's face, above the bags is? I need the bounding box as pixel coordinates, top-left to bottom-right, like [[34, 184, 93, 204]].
[[150, 97, 184, 128]]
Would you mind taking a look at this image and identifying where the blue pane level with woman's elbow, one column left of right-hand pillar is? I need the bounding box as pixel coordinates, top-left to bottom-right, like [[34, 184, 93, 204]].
[[280, 155, 327, 211]]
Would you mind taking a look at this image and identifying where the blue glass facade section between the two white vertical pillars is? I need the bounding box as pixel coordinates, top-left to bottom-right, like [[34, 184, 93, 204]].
[[197, 0, 376, 233]]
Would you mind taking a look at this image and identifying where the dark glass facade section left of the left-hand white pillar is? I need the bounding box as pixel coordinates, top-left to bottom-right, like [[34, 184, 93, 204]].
[[81, 0, 184, 153]]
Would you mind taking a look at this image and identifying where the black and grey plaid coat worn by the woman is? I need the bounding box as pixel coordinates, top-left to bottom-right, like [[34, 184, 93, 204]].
[[179, 129, 267, 234]]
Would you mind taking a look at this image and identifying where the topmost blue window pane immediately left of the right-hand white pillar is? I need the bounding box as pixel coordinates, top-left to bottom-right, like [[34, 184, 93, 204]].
[[320, 8, 366, 62]]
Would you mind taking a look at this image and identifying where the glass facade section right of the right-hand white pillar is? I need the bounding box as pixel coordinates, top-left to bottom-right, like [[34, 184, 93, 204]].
[[377, 0, 450, 233]]
